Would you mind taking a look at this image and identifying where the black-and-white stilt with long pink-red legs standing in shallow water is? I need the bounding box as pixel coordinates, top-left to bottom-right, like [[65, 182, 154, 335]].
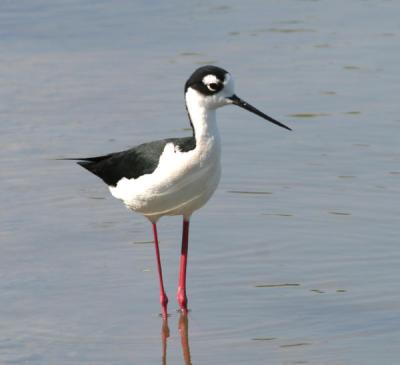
[[66, 66, 290, 318]]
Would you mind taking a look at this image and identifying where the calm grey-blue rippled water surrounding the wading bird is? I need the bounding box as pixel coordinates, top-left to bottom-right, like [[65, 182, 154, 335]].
[[0, 0, 400, 365]]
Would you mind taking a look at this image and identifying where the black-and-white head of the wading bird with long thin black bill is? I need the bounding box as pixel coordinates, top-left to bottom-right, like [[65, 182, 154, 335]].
[[185, 65, 291, 130]]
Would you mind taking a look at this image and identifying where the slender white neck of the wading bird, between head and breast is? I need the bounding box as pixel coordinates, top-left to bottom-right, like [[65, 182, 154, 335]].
[[185, 88, 220, 146]]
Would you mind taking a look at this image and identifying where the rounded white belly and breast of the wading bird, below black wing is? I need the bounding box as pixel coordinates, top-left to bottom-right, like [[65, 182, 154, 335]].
[[110, 140, 221, 222]]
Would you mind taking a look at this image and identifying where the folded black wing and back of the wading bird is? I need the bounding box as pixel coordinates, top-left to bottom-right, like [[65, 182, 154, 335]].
[[76, 137, 196, 186]]
